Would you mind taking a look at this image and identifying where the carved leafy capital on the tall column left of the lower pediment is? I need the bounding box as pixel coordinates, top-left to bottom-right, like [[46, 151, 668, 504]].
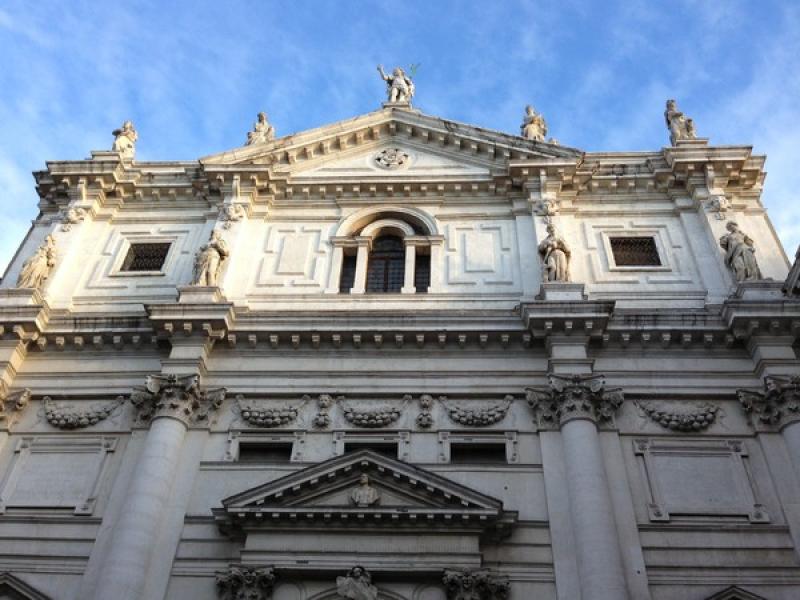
[[131, 375, 225, 426]]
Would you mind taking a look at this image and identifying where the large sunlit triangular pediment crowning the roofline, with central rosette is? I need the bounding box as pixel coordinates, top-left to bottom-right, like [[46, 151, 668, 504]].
[[200, 108, 582, 180]]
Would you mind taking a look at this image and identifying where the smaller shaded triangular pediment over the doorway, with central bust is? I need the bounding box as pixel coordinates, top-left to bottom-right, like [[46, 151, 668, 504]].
[[214, 450, 516, 529]]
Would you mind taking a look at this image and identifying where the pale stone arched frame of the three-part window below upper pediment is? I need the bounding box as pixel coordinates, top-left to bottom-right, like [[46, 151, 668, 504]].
[[326, 207, 444, 295]]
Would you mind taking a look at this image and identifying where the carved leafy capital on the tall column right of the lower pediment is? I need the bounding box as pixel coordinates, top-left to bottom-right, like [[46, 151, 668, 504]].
[[525, 374, 624, 429]]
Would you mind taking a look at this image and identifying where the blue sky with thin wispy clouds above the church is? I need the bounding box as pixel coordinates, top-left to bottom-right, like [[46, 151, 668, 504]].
[[0, 0, 800, 271]]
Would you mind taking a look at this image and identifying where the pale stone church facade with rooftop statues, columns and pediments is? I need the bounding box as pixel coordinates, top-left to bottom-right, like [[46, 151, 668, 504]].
[[0, 74, 800, 600]]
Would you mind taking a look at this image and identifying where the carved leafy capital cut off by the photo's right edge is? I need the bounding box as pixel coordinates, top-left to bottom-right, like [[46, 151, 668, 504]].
[[736, 375, 800, 429]]
